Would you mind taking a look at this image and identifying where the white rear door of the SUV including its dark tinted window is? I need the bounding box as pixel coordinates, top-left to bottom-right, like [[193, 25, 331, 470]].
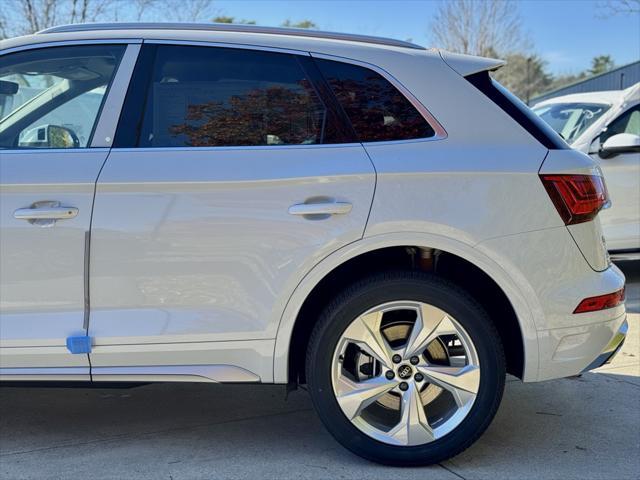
[[90, 42, 375, 381]]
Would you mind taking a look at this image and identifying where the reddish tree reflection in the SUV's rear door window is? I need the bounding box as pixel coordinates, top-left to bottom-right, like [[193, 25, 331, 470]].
[[169, 82, 325, 147]]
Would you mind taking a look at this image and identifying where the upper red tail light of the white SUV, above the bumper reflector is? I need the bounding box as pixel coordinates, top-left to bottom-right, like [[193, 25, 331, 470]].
[[540, 175, 609, 225]]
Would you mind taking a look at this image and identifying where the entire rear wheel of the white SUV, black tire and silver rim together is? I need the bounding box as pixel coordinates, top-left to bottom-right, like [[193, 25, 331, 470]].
[[306, 272, 505, 465]]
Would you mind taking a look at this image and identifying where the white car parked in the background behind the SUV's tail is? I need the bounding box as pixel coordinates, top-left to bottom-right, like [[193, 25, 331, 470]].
[[533, 83, 640, 260]]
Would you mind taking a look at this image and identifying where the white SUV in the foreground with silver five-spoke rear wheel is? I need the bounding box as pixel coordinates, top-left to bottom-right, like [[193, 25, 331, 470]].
[[0, 24, 627, 465]]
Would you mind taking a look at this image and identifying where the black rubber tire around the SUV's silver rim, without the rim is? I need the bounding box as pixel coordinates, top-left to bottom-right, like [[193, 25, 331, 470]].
[[306, 272, 505, 466]]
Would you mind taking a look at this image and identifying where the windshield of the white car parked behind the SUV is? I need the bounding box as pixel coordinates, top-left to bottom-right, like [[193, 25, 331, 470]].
[[533, 103, 610, 143]]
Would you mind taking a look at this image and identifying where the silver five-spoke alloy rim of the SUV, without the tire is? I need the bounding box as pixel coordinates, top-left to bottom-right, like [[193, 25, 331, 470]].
[[331, 301, 480, 446]]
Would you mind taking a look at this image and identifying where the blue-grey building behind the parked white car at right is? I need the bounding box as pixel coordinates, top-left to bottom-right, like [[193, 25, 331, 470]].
[[529, 60, 640, 105]]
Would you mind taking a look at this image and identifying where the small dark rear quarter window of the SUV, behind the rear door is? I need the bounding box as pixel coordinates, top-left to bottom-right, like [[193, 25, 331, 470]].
[[316, 60, 435, 142]]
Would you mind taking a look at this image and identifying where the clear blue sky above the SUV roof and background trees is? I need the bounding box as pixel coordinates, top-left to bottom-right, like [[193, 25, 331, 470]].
[[215, 0, 640, 75]]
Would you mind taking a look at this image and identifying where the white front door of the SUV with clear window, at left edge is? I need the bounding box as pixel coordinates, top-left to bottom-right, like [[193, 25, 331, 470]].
[[0, 42, 134, 379]]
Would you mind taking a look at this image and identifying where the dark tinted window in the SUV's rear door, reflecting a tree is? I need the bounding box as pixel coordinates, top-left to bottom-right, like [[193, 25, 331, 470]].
[[139, 45, 327, 147]]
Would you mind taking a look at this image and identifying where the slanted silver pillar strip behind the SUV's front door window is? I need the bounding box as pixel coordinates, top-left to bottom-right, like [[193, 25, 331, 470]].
[[89, 43, 142, 148]]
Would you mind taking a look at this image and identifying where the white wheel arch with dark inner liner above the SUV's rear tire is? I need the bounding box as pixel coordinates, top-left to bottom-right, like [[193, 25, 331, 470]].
[[274, 232, 538, 383]]
